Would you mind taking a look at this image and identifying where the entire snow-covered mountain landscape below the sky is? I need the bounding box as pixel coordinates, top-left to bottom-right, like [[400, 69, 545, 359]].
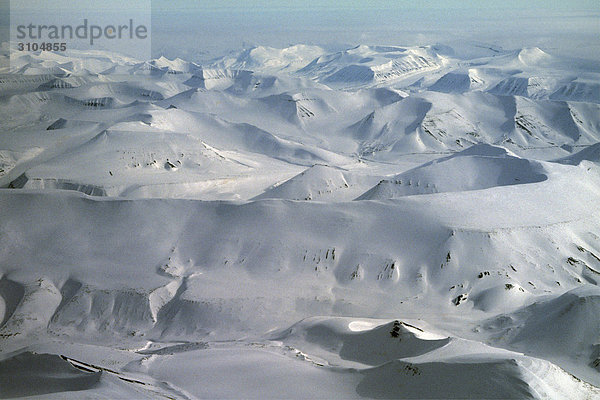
[[0, 45, 600, 399]]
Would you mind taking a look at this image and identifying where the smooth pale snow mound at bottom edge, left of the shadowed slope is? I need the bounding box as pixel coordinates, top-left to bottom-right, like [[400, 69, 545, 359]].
[[128, 343, 362, 399]]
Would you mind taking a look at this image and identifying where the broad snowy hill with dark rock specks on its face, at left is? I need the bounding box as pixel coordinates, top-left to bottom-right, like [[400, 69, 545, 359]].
[[19, 126, 251, 197]]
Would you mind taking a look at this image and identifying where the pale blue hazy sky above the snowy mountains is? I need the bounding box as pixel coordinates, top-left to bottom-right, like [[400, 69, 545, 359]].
[[0, 0, 600, 60]]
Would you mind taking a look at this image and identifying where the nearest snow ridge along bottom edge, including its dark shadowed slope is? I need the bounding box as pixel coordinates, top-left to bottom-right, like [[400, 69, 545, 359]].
[[127, 337, 598, 399]]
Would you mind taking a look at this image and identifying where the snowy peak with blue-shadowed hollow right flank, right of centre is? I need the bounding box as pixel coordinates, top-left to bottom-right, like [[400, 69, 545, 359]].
[[357, 145, 548, 200]]
